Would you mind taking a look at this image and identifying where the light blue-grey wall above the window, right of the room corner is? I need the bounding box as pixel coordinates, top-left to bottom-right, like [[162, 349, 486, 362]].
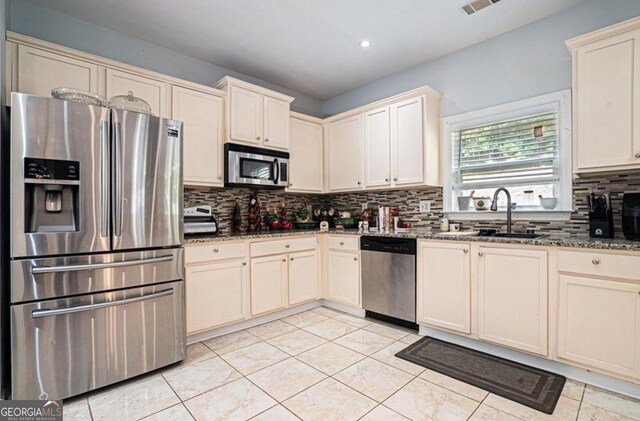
[[323, 0, 640, 116]]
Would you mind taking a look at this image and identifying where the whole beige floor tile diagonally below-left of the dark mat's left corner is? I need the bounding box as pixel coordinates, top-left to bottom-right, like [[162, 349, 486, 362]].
[[333, 358, 414, 402]]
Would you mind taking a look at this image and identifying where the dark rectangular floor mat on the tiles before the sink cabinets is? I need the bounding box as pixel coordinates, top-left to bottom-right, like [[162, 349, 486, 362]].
[[396, 336, 567, 414]]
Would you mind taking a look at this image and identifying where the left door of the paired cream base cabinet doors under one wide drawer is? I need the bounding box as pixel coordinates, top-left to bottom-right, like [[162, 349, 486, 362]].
[[251, 254, 287, 316]]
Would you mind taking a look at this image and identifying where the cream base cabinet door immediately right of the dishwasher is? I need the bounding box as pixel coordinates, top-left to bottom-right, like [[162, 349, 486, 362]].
[[418, 243, 471, 334]]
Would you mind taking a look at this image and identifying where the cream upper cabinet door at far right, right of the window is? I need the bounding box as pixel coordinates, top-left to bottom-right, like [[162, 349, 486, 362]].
[[574, 30, 640, 169]]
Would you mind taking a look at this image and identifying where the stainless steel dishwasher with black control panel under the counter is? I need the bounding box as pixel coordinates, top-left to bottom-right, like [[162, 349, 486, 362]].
[[360, 236, 416, 326]]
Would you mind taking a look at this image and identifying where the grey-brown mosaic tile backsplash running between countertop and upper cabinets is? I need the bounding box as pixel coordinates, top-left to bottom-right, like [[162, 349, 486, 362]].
[[184, 173, 640, 237]]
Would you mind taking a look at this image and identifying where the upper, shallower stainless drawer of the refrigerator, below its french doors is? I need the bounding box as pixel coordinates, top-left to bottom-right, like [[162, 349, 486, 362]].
[[11, 248, 184, 303]]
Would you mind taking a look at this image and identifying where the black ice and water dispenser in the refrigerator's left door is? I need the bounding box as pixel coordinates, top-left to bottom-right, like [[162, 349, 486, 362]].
[[24, 158, 80, 233]]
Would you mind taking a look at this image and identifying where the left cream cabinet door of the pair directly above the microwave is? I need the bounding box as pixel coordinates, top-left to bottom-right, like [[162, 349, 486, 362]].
[[229, 86, 262, 143]]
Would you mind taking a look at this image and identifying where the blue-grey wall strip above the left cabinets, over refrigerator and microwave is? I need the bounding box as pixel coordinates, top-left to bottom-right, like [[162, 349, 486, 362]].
[[2, 0, 322, 116]]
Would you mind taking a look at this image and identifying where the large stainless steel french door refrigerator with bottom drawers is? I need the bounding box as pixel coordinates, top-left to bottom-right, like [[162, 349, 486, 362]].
[[3, 93, 186, 399]]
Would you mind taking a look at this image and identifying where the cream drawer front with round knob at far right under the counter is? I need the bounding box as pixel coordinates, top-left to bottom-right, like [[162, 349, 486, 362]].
[[558, 250, 640, 281]]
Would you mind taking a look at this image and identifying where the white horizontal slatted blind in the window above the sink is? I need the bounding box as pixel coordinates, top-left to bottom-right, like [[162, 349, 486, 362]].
[[451, 112, 560, 190]]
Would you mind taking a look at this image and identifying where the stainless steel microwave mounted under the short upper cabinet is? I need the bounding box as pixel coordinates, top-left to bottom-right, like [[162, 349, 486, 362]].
[[224, 143, 289, 188]]
